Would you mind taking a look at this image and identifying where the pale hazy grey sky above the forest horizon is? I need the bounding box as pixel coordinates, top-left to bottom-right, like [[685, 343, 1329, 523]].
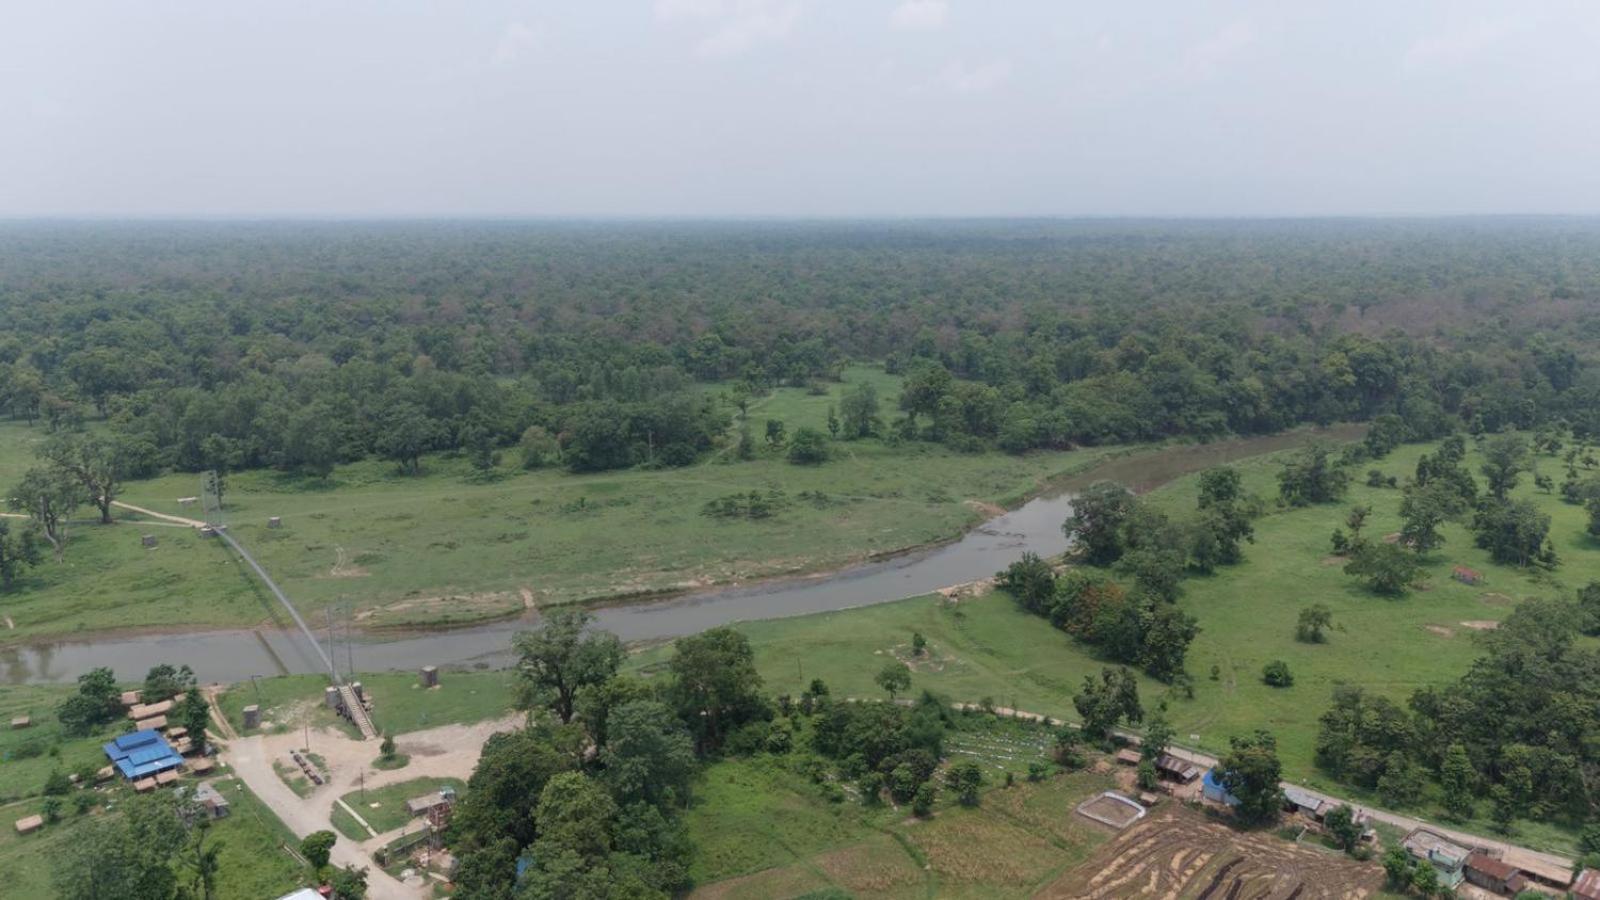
[[0, 0, 1600, 216]]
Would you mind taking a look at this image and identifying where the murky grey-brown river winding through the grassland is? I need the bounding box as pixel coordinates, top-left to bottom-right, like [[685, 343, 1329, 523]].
[[0, 426, 1363, 684]]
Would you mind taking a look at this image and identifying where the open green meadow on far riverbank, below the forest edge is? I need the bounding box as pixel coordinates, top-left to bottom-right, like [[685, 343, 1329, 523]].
[[0, 368, 1126, 644]]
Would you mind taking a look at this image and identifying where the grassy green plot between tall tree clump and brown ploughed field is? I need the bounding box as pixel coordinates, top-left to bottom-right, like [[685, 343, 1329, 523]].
[[686, 756, 1112, 898]]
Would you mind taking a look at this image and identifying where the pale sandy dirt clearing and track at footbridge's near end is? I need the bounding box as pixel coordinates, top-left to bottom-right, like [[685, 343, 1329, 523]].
[[222, 714, 523, 900]]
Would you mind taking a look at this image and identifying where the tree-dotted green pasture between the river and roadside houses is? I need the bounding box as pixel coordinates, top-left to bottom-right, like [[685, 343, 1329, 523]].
[[632, 432, 1600, 849]]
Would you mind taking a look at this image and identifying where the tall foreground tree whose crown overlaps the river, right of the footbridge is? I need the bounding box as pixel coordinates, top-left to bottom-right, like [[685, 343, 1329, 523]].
[[512, 609, 626, 724]]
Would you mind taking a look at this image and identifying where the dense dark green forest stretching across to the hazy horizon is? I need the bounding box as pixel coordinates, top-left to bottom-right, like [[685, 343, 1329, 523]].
[[0, 219, 1600, 472]]
